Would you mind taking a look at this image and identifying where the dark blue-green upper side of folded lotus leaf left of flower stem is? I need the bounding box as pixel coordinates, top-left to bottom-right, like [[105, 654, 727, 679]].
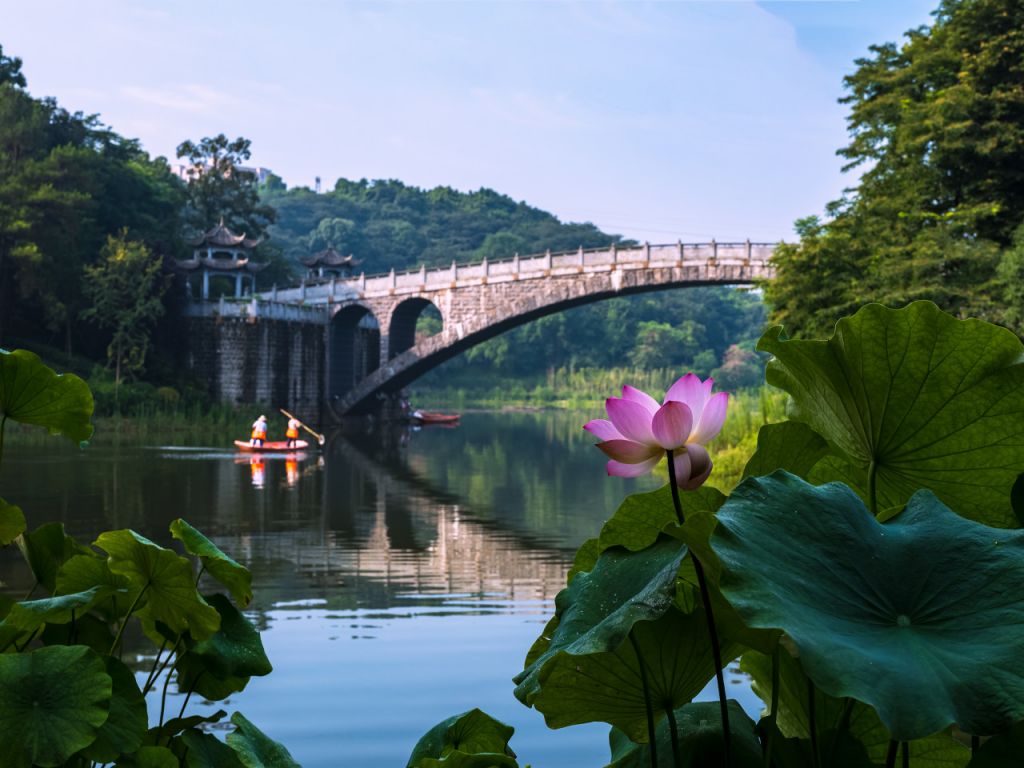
[[515, 538, 686, 707]]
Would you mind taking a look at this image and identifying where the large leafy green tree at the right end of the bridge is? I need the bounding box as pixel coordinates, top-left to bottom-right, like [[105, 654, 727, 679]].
[[766, 0, 1024, 335]]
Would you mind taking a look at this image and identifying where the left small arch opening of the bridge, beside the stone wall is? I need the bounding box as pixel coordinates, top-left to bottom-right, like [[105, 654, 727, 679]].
[[327, 304, 381, 399]]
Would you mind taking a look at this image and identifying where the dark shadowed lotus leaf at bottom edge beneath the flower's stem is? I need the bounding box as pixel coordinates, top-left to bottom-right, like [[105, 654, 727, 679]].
[[606, 699, 764, 768]]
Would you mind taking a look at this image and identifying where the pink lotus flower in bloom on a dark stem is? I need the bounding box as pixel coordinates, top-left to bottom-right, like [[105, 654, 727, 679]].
[[584, 374, 729, 490]]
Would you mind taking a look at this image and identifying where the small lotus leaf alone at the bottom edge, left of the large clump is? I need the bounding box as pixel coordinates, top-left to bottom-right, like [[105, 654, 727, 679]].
[[407, 710, 518, 768]]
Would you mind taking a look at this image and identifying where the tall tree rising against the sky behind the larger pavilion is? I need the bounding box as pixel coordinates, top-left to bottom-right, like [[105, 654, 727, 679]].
[[177, 133, 276, 239]]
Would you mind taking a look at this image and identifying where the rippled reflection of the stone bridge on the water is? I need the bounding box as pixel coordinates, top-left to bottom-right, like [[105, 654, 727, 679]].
[[228, 437, 571, 607]]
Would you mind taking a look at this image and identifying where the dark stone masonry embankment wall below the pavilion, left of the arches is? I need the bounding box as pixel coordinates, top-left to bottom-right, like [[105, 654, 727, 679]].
[[185, 317, 327, 425]]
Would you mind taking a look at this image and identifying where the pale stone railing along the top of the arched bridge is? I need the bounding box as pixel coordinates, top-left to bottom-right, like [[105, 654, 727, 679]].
[[263, 241, 777, 304]]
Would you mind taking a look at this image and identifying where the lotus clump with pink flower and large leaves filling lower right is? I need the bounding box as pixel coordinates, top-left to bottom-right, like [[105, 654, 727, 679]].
[[408, 301, 1024, 768]]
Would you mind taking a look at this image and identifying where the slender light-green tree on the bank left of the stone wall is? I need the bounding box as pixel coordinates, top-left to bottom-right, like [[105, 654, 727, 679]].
[[82, 230, 166, 391]]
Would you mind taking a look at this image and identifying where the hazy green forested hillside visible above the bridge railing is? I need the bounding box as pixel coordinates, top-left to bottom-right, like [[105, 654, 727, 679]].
[[263, 178, 624, 274]]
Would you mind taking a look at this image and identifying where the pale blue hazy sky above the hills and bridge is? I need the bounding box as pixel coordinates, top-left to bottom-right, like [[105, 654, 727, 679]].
[[0, 0, 938, 243]]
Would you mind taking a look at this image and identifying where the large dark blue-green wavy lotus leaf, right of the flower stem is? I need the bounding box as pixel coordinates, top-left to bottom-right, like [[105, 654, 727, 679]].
[[712, 472, 1024, 741]]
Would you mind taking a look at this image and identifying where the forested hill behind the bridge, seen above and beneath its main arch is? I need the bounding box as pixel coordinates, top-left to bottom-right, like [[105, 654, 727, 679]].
[[262, 177, 764, 389]]
